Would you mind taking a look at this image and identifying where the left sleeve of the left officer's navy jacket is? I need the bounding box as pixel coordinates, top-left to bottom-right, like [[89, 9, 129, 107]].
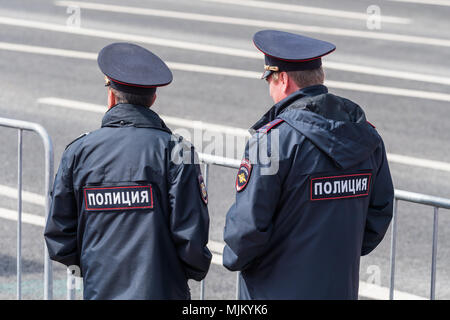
[[44, 150, 80, 266]]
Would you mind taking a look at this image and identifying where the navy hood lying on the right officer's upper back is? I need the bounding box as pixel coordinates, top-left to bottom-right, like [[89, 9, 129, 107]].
[[278, 87, 381, 169]]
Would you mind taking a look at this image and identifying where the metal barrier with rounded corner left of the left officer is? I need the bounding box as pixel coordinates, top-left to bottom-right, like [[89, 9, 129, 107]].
[[0, 118, 53, 300]]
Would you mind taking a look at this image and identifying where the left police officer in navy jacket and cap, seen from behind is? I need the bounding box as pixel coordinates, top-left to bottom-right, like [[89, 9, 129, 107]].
[[45, 43, 211, 299]]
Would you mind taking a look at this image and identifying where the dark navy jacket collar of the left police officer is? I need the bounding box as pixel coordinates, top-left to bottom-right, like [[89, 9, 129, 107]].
[[102, 103, 171, 133]]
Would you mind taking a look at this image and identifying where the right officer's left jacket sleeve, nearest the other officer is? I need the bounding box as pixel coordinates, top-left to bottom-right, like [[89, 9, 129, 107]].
[[223, 134, 281, 271]]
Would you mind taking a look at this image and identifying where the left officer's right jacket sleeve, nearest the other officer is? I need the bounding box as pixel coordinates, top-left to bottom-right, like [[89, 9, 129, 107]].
[[169, 142, 212, 281]]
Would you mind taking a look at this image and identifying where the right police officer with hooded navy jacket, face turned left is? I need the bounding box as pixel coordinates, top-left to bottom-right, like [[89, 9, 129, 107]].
[[223, 30, 394, 299]]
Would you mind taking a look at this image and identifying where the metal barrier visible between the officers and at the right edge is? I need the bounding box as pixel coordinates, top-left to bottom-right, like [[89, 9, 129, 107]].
[[199, 153, 450, 300]]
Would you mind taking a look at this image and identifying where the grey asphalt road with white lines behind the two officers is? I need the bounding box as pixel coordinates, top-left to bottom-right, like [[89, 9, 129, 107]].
[[0, 0, 450, 299]]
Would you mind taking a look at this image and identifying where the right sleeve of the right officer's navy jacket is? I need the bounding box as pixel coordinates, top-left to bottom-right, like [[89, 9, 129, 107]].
[[361, 142, 394, 256]]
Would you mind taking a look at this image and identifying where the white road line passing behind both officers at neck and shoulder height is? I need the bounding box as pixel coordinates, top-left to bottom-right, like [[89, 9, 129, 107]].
[[37, 97, 450, 172]]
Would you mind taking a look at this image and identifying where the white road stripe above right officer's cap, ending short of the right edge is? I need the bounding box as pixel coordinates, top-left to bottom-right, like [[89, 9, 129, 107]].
[[201, 0, 411, 24]]
